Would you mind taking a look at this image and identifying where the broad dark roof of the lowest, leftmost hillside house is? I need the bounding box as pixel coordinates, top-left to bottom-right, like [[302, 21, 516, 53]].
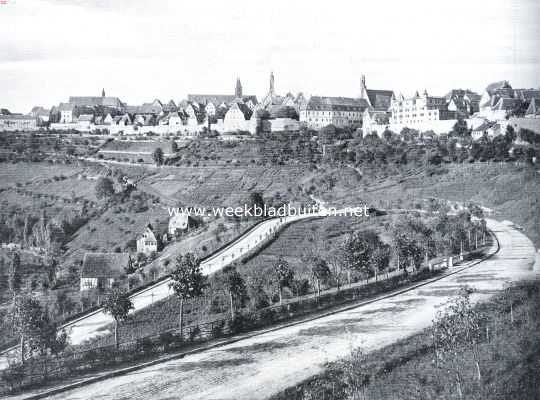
[[81, 253, 131, 278]]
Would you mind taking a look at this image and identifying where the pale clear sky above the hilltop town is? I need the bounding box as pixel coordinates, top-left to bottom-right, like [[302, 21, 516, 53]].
[[0, 0, 540, 113]]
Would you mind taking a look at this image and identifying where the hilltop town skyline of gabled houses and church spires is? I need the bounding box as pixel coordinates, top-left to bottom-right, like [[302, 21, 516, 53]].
[[4, 73, 540, 135]]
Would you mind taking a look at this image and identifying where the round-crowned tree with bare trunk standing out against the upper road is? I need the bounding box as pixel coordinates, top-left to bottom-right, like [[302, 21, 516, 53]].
[[169, 253, 208, 338]]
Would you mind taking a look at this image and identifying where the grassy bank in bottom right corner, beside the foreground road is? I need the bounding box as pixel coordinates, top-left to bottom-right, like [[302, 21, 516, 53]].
[[272, 281, 540, 400]]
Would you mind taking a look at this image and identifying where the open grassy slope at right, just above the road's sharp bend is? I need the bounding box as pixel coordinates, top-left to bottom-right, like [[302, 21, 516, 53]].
[[317, 163, 540, 247]]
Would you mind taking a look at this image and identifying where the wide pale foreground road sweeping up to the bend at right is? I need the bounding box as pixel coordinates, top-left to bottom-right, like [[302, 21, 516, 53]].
[[7, 219, 540, 400]]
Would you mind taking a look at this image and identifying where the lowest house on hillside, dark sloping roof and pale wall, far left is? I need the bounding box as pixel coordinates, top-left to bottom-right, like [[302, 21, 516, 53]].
[[81, 253, 132, 291]]
